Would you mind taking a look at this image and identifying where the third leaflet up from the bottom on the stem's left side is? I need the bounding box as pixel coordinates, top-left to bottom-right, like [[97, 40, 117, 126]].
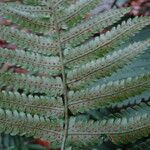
[[0, 73, 63, 96]]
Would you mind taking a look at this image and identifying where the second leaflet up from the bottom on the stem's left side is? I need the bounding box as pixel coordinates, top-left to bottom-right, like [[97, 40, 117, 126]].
[[0, 91, 64, 118]]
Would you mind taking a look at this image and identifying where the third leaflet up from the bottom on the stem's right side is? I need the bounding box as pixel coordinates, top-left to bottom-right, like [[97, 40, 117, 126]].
[[67, 40, 150, 89]]
